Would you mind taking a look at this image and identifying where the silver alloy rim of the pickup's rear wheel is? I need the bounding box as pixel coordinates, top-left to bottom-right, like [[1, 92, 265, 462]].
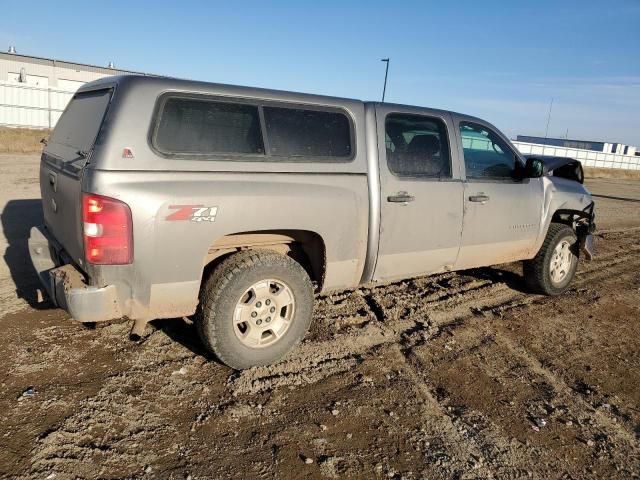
[[233, 279, 295, 348]]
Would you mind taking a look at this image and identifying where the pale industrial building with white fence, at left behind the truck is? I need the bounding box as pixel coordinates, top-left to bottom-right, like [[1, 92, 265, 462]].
[[0, 47, 144, 128]]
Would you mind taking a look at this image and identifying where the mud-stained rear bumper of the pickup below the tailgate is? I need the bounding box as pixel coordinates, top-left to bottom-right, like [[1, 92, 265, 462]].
[[29, 226, 123, 322]]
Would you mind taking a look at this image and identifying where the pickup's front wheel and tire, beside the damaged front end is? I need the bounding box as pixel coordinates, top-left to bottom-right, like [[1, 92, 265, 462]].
[[523, 223, 579, 295]]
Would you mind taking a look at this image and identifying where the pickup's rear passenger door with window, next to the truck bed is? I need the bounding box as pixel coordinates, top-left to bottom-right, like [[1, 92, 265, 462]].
[[374, 104, 462, 281]]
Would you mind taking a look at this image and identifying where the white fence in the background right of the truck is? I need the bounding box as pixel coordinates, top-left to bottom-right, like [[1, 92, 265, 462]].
[[513, 142, 640, 170]]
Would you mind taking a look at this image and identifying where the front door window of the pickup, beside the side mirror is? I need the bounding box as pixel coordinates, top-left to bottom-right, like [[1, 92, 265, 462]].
[[460, 122, 517, 180]]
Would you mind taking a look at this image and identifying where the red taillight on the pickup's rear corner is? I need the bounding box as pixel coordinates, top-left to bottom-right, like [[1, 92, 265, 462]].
[[82, 193, 133, 265]]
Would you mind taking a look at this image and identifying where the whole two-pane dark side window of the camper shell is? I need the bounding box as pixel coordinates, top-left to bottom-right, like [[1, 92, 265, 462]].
[[151, 93, 355, 163]]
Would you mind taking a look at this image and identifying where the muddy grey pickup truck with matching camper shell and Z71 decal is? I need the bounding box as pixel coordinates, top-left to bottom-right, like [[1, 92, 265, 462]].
[[29, 76, 594, 369]]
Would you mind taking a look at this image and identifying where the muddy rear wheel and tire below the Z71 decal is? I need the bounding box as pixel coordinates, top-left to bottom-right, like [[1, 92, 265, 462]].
[[195, 250, 314, 370]]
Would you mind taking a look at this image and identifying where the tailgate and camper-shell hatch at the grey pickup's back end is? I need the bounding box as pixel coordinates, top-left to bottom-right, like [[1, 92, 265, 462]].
[[40, 89, 112, 264]]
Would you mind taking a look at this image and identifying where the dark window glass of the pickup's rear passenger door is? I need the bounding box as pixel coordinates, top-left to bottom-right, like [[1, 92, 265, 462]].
[[385, 113, 451, 178]]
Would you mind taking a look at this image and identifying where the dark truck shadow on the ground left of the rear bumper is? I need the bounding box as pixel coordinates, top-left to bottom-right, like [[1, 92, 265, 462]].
[[0, 198, 52, 309]]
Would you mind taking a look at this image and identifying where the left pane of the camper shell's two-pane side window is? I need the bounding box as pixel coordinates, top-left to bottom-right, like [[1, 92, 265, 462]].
[[154, 97, 264, 154]]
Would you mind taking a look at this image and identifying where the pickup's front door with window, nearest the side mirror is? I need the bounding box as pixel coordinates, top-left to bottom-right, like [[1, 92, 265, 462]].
[[454, 116, 542, 269]]
